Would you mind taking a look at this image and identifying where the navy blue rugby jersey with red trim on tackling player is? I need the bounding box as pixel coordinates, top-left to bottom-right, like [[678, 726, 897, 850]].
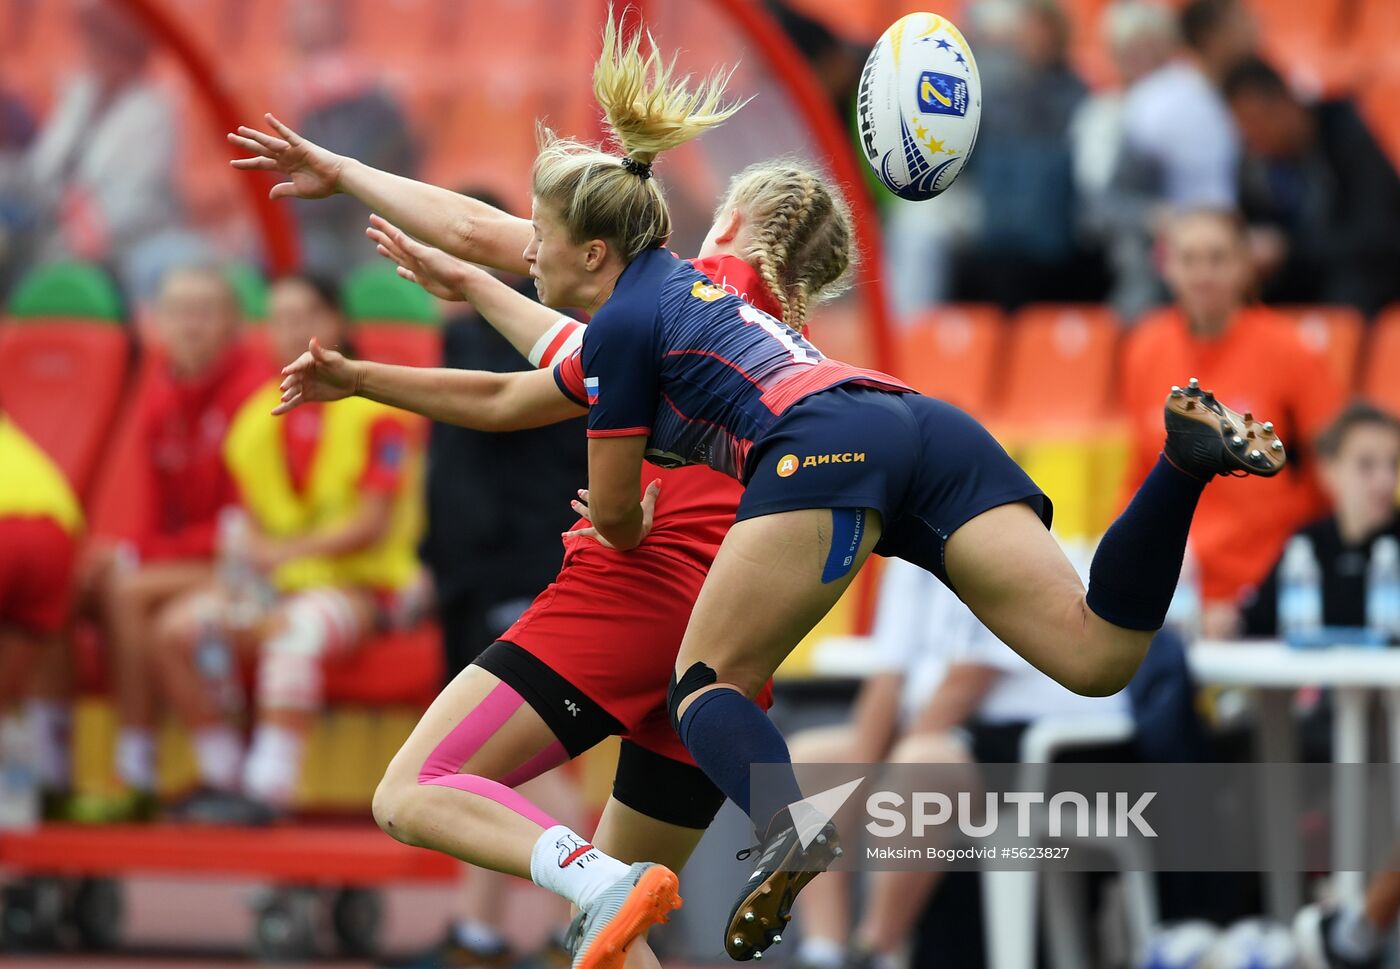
[[554, 248, 913, 479]]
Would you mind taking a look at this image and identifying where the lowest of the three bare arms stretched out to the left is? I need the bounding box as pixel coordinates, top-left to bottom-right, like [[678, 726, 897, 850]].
[[273, 340, 587, 431]]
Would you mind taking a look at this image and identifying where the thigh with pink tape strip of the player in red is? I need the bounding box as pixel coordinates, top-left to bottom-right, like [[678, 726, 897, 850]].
[[384, 665, 559, 784]]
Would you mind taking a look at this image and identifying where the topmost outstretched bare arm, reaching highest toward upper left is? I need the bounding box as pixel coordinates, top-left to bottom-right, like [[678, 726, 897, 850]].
[[228, 113, 532, 274]]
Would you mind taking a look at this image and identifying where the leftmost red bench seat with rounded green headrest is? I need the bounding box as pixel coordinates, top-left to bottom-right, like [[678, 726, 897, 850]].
[[0, 263, 130, 497]]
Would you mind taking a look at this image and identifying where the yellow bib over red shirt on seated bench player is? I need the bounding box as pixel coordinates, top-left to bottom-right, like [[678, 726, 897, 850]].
[[224, 381, 423, 591]]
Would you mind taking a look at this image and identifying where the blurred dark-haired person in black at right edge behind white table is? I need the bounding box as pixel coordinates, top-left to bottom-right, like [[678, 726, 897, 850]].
[[1242, 402, 1400, 637]]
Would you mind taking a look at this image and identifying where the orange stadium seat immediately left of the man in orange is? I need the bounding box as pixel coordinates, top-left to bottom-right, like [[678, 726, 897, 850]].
[[997, 302, 1119, 427]]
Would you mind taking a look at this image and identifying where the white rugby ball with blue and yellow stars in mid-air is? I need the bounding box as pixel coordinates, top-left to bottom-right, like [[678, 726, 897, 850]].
[[857, 13, 981, 202]]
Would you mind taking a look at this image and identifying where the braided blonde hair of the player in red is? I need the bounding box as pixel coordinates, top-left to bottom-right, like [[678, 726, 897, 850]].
[[715, 161, 855, 330]]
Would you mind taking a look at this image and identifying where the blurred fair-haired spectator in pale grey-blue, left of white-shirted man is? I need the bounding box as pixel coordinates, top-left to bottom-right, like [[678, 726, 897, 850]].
[[1070, 0, 1180, 319]]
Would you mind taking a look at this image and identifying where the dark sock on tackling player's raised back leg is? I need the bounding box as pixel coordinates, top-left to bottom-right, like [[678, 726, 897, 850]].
[[1088, 455, 1205, 630]]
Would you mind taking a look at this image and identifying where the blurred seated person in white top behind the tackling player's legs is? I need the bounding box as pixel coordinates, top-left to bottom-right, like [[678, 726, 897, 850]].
[[791, 559, 1133, 969]]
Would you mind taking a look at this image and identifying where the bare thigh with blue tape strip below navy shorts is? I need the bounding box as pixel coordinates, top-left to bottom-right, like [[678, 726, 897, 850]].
[[676, 508, 881, 696]]
